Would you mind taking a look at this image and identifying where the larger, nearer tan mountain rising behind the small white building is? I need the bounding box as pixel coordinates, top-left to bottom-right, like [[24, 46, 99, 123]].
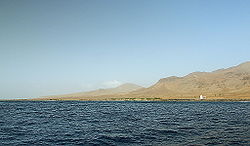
[[130, 62, 250, 98]]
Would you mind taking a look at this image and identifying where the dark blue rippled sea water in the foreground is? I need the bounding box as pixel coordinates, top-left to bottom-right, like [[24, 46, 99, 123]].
[[0, 101, 250, 145]]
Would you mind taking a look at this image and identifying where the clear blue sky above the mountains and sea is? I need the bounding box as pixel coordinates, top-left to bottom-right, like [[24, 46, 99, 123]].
[[0, 0, 250, 99]]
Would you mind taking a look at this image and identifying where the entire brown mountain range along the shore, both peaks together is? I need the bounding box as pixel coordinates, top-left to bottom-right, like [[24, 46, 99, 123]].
[[37, 62, 250, 100]]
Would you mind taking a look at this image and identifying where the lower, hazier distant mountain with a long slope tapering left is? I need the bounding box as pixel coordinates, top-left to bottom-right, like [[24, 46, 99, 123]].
[[44, 83, 143, 98]]
